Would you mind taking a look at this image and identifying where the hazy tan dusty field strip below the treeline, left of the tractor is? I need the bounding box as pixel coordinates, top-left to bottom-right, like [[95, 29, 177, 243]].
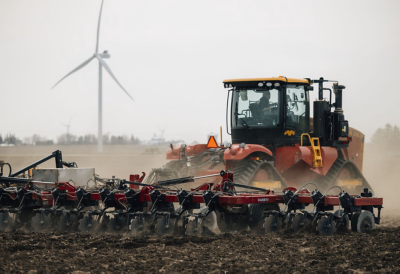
[[0, 145, 168, 180]]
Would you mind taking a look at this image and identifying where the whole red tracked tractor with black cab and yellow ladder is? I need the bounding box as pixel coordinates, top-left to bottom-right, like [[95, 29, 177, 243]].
[[146, 76, 371, 193]]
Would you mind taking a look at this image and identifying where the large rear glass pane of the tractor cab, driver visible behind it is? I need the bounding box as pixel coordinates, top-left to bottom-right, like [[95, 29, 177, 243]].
[[232, 88, 281, 128]]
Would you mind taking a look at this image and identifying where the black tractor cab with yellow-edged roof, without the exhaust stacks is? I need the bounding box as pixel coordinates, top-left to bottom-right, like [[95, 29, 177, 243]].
[[224, 77, 312, 147]]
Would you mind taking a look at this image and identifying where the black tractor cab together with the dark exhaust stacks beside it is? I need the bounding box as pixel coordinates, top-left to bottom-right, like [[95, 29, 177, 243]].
[[224, 76, 351, 150]]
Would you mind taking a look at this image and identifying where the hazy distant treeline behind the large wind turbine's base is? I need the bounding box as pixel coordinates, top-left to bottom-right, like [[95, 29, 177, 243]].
[[0, 133, 140, 146]]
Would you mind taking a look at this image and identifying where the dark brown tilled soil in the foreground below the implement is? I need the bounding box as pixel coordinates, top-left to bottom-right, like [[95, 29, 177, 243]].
[[0, 226, 400, 273]]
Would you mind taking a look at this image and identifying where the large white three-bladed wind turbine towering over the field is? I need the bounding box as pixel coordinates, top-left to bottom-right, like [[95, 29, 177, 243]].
[[51, 0, 133, 152]]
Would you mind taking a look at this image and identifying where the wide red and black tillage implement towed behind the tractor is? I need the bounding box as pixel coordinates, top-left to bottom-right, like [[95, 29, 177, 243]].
[[0, 151, 383, 237]]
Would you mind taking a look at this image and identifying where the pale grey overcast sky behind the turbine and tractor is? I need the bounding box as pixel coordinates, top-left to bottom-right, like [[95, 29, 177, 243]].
[[0, 0, 400, 143]]
